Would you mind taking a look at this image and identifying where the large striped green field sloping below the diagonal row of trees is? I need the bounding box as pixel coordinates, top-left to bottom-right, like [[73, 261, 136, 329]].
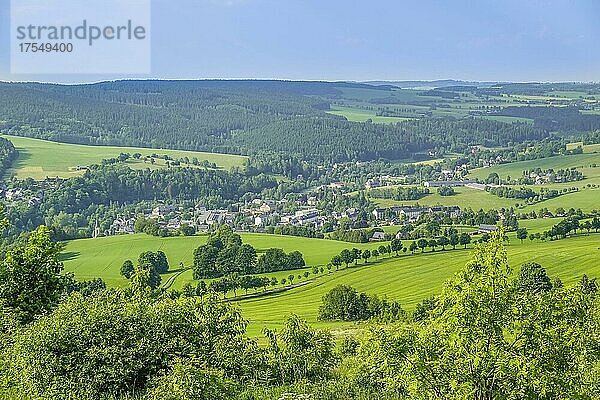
[[239, 234, 600, 336]]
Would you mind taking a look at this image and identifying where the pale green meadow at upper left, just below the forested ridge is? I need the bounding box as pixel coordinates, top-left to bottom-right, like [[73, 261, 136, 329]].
[[3, 135, 246, 179]]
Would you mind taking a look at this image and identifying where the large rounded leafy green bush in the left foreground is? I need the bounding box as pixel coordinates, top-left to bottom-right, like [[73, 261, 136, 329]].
[[8, 292, 257, 398]]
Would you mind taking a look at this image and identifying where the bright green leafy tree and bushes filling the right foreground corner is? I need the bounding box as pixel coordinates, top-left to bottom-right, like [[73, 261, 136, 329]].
[[344, 231, 600, 399]]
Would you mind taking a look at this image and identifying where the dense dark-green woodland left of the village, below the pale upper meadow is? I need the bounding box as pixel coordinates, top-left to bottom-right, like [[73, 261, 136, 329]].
[[5, 164, 277, 238]]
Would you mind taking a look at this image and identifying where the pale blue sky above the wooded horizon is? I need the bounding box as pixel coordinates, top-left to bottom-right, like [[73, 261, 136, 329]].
[[0, 0, 600, 82]]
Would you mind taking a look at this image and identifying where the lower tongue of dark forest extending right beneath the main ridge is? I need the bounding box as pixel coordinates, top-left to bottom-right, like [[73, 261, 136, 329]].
[[232, 117, 545, 162]]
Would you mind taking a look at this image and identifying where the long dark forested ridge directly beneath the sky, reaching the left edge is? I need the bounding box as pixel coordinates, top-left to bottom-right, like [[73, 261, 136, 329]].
[[0, 81, 546, 161]]
